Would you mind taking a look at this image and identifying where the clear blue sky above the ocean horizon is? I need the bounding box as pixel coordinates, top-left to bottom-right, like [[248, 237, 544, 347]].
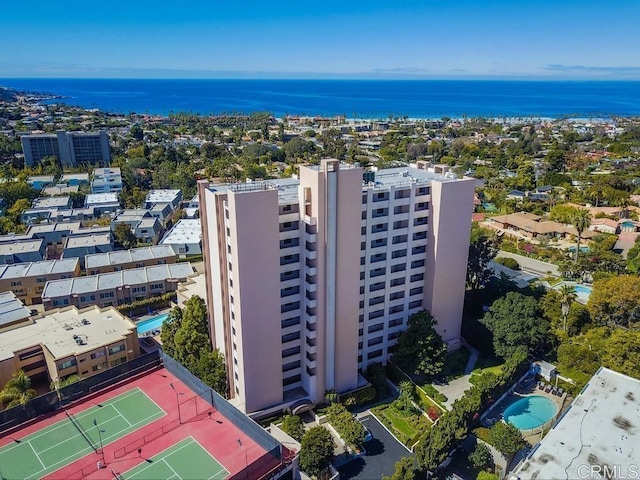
[[0, 0, 640, 79]]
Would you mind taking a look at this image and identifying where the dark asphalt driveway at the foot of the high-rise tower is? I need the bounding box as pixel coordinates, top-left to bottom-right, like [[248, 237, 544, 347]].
[[338, 415, 413, 480]]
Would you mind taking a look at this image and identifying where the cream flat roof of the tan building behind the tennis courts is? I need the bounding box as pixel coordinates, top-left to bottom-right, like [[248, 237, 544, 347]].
[[0, 306, 136, 361]]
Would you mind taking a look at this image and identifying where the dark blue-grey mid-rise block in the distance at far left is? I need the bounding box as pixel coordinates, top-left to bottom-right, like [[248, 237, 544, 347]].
[[20, 130, 111, 167]]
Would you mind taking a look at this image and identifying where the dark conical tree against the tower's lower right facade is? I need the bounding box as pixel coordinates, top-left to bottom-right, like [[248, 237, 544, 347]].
[[393, 310, 447, 376]]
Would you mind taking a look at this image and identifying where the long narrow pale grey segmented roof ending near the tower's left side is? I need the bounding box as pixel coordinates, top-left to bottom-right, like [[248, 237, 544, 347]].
[[42, 262, 194, 298]]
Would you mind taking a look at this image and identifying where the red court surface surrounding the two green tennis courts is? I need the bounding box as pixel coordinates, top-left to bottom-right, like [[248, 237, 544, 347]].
[[0, 368, 280, 480]]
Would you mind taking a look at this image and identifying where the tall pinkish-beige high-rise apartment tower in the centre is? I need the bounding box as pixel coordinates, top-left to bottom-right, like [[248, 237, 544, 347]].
[[199, 160, 474, 412]]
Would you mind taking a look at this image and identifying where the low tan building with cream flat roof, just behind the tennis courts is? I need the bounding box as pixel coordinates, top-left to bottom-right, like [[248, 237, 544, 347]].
[[0, 306, 140, 385]]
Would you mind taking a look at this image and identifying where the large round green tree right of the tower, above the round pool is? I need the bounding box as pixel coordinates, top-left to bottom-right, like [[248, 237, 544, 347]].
[[480, 292, 551, 358]]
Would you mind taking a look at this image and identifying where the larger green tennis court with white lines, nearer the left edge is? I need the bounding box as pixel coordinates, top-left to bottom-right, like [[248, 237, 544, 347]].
[[0, 388, 166, 479]]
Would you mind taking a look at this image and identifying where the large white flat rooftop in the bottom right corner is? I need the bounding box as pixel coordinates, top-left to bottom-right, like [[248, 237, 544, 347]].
[[511, 367, 640, 480]]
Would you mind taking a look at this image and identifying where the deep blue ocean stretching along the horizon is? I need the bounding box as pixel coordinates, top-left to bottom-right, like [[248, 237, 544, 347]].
[[0, 79, 640, 118]]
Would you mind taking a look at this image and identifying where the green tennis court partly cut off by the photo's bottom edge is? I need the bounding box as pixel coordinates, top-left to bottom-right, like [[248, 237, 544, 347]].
[[121, 437, 229, 480]]
